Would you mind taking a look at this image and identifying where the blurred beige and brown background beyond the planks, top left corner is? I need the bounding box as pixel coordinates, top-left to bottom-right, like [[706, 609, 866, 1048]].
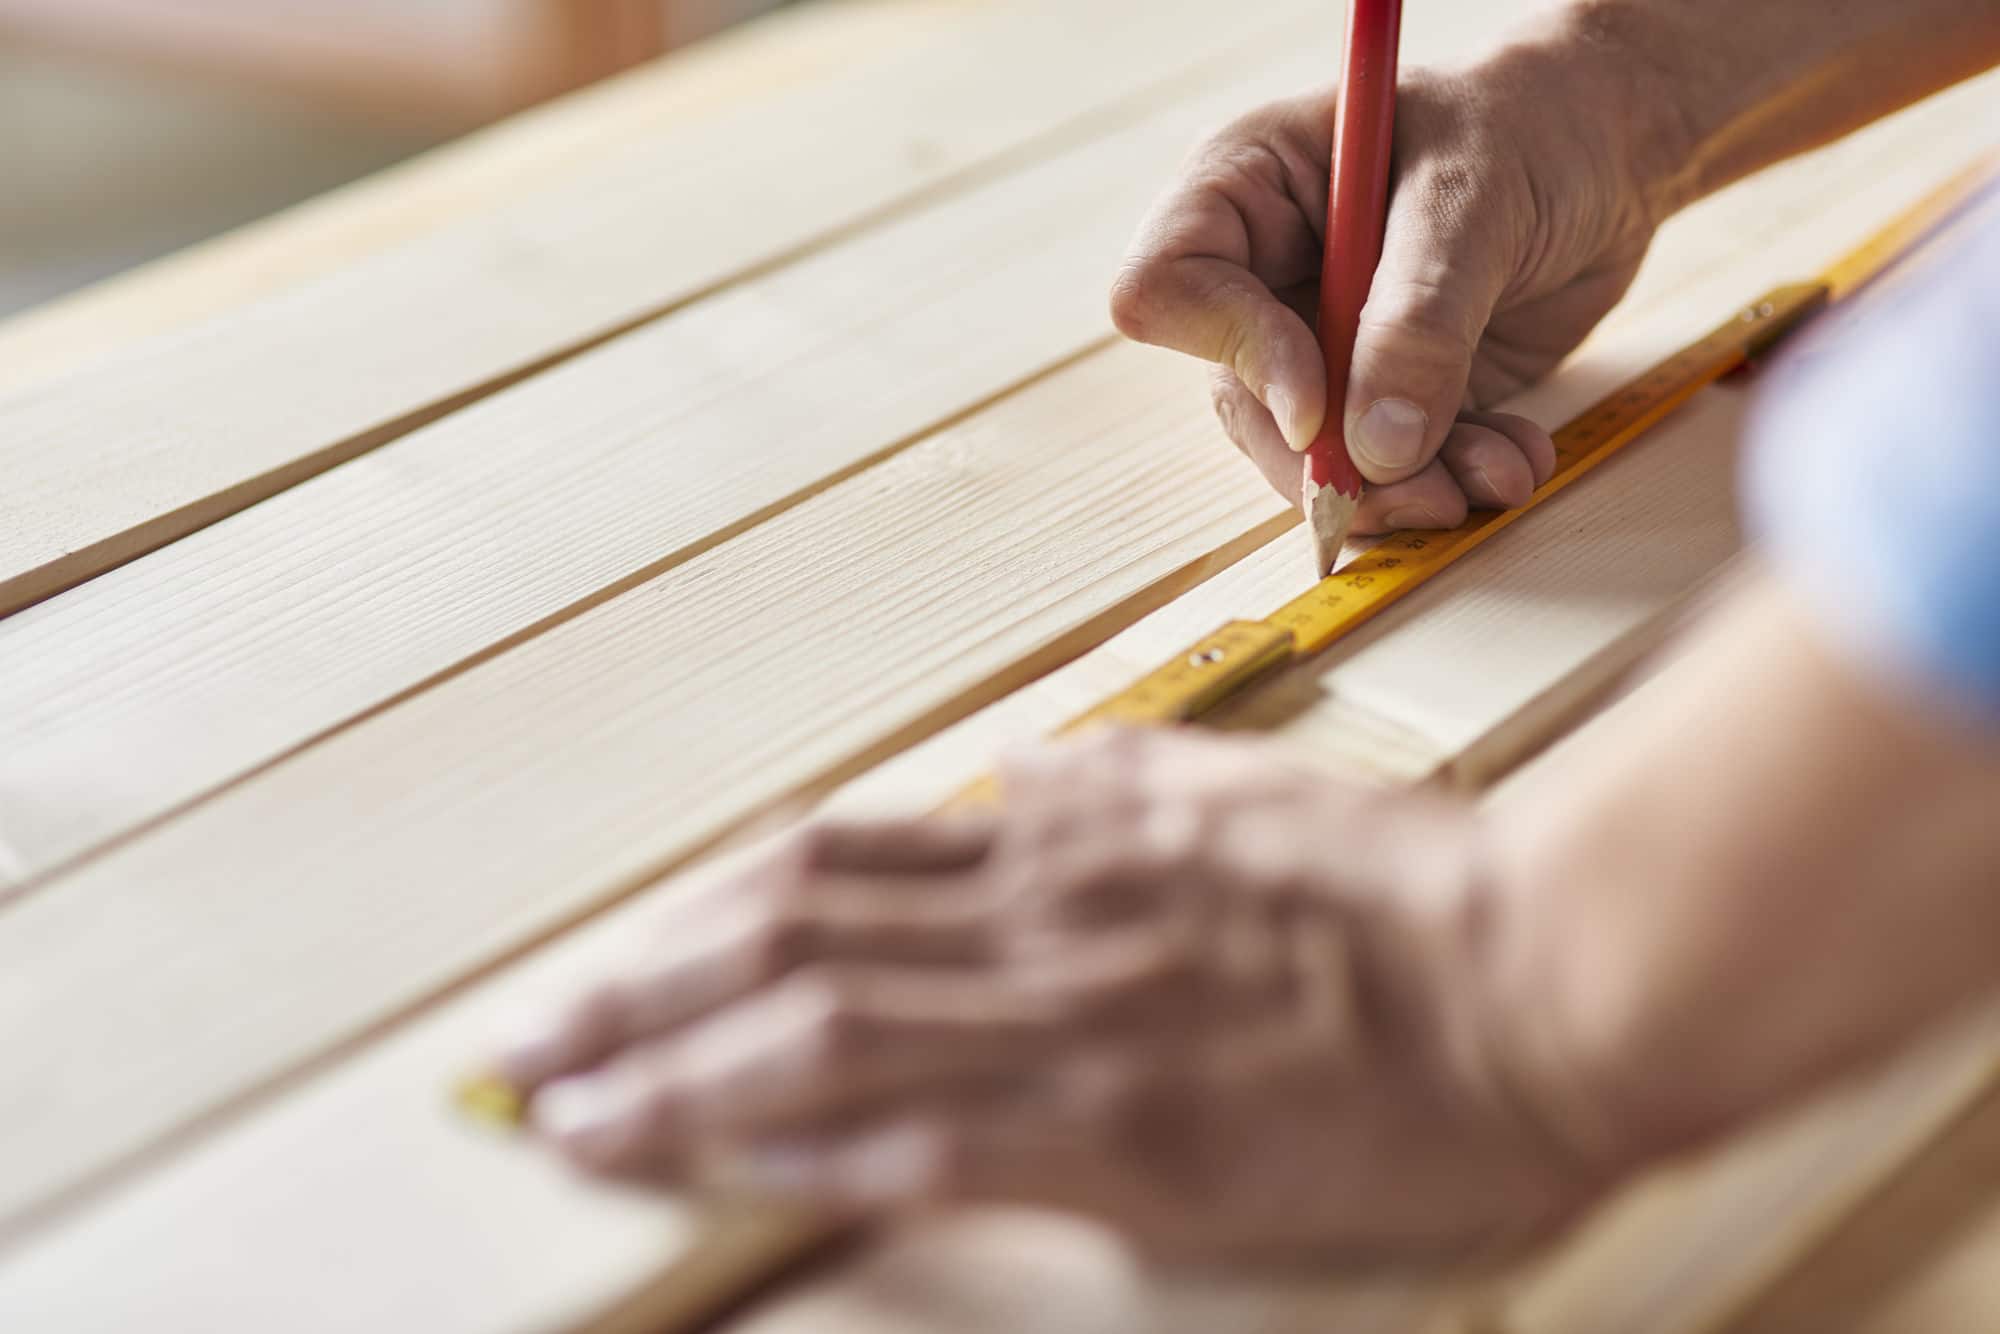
[[0, 0, 786, 316]]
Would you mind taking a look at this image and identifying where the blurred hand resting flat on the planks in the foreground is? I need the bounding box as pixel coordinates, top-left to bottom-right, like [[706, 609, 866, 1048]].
[[502, 734, 1600, 1262]]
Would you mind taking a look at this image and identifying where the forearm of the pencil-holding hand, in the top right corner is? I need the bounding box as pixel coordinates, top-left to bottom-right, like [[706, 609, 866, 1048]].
[[1526, 0, 2000, 216]]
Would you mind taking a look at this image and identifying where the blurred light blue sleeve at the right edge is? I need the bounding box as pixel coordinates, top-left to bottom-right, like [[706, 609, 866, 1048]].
[[1744, 226, 2000, 726]]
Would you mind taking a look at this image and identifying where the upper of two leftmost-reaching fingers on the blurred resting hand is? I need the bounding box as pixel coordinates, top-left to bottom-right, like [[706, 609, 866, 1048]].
[[500, 874, 992, 1092]]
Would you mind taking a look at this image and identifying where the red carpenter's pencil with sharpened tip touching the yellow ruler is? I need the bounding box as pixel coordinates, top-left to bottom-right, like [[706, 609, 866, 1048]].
[[1302, 0, 1402, 576]]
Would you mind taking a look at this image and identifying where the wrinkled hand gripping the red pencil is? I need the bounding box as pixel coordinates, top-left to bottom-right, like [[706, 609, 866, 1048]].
[[1112, 58, 1664, 532]]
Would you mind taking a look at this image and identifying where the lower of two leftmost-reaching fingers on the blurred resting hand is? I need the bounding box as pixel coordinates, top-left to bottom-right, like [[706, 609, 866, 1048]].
[[530, 934, 1248, 1172]]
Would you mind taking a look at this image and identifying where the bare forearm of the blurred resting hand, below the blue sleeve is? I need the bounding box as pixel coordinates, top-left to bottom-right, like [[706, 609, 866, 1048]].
[[1486, 578, 2000, 1158]]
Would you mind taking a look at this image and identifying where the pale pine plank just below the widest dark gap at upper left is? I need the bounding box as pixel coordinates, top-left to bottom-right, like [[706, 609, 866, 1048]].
[[0, 60, 1984, 902]]
